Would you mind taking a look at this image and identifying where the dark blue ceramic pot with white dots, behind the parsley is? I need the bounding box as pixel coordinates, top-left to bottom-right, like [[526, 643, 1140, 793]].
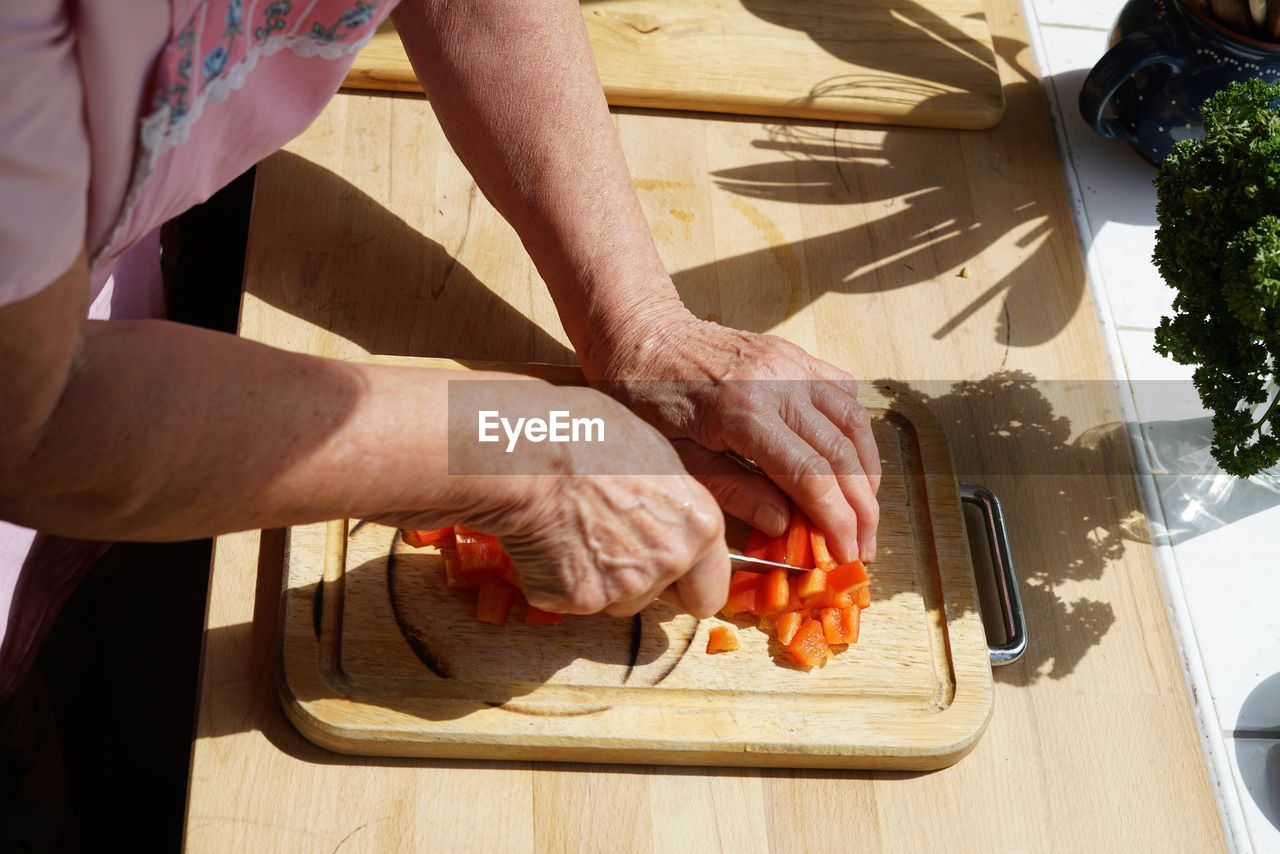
[[1080, 0, 1280, 164]]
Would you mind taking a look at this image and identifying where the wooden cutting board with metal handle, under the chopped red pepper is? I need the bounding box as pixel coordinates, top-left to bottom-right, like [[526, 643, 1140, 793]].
[[279, 357, 992, 769]]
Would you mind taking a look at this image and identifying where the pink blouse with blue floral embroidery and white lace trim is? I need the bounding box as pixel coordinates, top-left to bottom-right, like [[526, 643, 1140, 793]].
[[0, 0, 397, 699]]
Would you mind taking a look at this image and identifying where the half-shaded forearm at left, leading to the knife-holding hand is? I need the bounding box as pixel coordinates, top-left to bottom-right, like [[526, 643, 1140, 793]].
[[0, 321, 514, 540]]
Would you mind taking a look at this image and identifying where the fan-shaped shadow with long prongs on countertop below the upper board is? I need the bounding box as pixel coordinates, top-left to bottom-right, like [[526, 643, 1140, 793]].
[[701, 38, 1084, 347]]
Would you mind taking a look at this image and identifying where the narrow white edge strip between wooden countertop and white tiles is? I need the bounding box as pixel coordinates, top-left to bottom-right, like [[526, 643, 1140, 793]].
[[1008, 0, 1252, 851]]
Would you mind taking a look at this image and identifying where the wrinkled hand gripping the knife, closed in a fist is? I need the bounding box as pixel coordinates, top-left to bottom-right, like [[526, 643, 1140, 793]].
[[381, 380, 730, 617]]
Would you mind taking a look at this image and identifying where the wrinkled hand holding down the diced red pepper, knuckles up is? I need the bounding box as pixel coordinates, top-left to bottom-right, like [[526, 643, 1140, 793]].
[[584, 306, 881, 561]]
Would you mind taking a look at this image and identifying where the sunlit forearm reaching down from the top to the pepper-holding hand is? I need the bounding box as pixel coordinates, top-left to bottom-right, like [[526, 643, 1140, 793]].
[[396, 0, 678, 361]]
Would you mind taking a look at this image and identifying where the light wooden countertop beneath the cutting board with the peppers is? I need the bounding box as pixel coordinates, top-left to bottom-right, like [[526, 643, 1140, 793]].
[[187, 0, 1224, 851]]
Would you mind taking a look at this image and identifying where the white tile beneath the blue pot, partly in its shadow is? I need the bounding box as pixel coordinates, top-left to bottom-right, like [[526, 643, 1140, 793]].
[[1041, 27, 1174, 328]]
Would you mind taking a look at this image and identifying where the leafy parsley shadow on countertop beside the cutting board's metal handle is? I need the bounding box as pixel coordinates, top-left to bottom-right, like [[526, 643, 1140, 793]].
[[876, 371, 1131, 685]]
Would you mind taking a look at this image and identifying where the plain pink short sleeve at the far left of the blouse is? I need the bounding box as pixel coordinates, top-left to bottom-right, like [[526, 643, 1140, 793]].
[[0, 0, 90, 305]]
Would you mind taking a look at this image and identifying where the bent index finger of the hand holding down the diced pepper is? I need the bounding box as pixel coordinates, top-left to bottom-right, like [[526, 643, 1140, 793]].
[[726, 412, 874, 560]]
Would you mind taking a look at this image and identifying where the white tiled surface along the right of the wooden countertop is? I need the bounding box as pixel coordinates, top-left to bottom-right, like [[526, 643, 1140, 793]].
[[1025, 6, 1280, 854]]
